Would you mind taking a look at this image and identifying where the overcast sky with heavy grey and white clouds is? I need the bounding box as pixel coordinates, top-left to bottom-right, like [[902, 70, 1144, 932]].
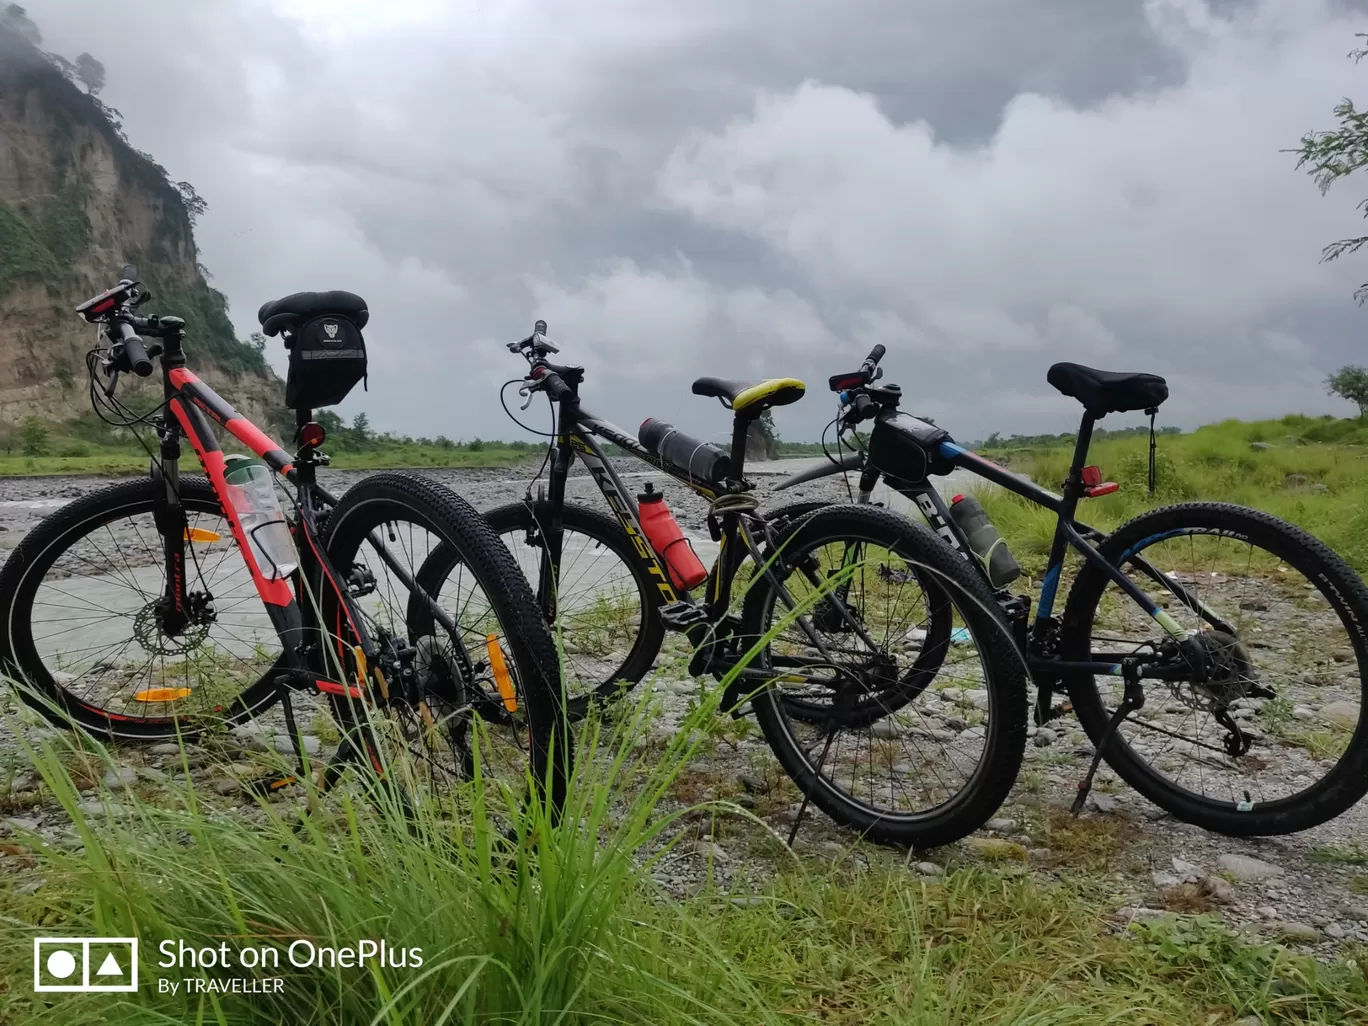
[[26, 0, 1368, 439]]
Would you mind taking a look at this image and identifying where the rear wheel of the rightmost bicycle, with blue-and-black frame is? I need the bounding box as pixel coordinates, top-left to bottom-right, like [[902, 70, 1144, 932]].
[[1062, 502, 1368, 836]]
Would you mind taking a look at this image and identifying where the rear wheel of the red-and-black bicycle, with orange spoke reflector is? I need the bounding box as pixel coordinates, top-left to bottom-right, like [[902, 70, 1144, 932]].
[[320, 473, 572, 811]]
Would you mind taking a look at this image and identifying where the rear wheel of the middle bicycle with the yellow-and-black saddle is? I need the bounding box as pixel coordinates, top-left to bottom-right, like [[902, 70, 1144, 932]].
[[743, 506, 1026, 848]]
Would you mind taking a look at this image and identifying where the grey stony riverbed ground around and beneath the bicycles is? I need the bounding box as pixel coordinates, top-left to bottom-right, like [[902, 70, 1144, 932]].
[[0, 466, 1368, 955]]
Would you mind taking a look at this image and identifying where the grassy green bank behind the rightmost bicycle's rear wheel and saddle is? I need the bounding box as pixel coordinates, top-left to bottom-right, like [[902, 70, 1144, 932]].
[[981, 415, 1368, 572]]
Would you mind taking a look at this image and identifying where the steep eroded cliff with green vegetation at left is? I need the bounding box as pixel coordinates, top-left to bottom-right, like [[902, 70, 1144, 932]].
[[0, 25, 283, 423]]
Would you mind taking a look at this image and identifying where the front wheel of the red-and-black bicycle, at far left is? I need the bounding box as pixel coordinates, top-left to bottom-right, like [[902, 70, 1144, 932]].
[[0, 477, 282, 740]]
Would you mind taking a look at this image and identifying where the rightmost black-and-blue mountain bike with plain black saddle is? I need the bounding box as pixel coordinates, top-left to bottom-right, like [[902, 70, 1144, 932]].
[[778, 346, 1368, 834]]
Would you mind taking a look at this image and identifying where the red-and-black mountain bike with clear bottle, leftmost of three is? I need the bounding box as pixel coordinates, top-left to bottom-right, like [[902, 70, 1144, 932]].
[[0, 267, 570, 820]]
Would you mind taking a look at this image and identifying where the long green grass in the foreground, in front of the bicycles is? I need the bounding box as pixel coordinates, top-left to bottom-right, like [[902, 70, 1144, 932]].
[[0, 694, 1368, 1026]]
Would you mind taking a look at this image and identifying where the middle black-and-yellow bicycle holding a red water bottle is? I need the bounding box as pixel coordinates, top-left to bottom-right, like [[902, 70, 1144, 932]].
[[419, 321, 1026, 847]]
